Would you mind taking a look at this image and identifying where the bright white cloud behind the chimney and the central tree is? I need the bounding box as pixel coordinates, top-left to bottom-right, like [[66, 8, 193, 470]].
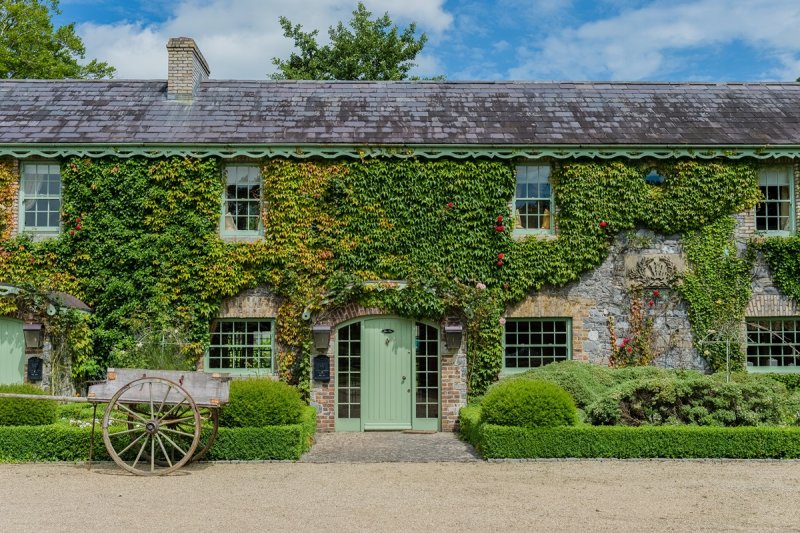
[[77, 0, 452, 79]]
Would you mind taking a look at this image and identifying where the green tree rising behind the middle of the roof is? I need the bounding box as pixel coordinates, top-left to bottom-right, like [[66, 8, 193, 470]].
[[270, 2, 428, 80]]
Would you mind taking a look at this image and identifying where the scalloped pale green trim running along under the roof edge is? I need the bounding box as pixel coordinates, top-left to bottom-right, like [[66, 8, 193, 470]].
[[0, 143, 800, 160]]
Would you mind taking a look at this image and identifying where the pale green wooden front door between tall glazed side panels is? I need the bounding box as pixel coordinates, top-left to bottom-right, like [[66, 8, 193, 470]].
[[361, 318, 413, 431]]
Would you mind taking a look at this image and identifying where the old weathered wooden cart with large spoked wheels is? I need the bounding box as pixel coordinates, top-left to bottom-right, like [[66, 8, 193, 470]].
[[0, 368, 230, 476]]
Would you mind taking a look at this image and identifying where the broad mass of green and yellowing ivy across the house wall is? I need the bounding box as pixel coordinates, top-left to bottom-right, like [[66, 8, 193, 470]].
[[0, 154, 759, 394]]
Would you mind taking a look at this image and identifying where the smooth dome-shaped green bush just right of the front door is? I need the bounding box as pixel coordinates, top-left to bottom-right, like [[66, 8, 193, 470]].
[[481, 379, 578, 427]]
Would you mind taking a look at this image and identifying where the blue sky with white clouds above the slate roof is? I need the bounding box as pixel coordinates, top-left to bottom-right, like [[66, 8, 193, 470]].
[[56, 0, 800, 81]]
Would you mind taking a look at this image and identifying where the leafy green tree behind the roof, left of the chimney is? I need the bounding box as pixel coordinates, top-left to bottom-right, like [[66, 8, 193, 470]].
[[0, 0, 116, 79]]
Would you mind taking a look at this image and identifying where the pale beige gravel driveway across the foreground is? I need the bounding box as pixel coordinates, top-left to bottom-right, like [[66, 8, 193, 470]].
[[0, 460, 800, 532]]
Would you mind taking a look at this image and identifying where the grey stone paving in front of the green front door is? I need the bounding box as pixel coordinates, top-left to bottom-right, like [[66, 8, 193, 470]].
[[300, 431, 482, 463]]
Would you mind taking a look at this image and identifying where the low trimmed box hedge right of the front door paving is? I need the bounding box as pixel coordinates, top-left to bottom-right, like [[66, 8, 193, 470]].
[[460, 406, 800, 459]]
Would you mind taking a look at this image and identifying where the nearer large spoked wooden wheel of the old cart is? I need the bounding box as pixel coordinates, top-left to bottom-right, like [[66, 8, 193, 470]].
[[103, 377, 202, 476]]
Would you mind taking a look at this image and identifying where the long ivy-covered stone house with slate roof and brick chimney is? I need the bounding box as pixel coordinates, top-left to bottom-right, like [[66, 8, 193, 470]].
[[0, 38, 800, 431]]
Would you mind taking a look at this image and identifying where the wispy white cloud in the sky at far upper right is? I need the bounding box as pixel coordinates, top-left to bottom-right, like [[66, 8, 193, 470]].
[[510, 0, 800, 80]]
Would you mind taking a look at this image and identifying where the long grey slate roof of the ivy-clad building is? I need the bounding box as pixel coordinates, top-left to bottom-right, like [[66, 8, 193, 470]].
[[0, 80, 800, 146]]
